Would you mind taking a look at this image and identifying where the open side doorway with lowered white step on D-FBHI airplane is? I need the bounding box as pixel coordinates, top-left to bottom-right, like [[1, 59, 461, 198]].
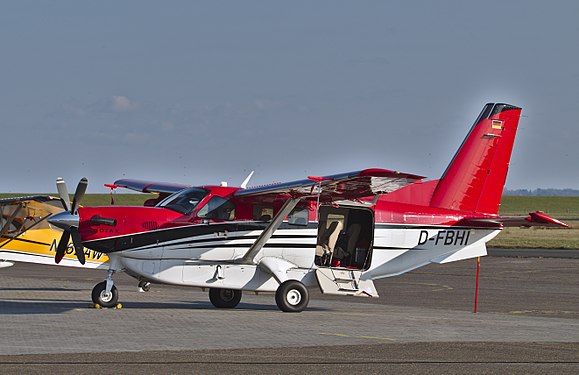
[[315, 206, 378, 297]]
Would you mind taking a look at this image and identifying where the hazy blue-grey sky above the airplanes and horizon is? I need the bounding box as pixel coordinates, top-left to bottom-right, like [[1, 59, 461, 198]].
[[0, 0, 579, 192]]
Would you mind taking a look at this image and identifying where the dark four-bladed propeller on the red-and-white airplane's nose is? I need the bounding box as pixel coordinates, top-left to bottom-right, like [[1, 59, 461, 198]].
[[48, 177, 88, 264]]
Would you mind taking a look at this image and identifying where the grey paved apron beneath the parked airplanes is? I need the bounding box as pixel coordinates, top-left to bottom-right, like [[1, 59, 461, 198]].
[[0, 257, 579, 374]]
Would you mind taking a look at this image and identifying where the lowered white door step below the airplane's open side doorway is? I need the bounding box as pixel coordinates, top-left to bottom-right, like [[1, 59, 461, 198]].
[[316, 268, 378, 297]]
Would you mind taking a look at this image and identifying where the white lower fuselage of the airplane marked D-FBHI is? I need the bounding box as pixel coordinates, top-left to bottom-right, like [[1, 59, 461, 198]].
[[115, 226, 499, 292]]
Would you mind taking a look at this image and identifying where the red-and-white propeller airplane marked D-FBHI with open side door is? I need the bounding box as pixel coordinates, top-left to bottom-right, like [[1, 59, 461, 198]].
[[49, 103, 566, 312]]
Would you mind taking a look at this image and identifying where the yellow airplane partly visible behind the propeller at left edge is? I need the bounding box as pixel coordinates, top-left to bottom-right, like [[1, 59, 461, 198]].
[[0, 195, 109, 269]]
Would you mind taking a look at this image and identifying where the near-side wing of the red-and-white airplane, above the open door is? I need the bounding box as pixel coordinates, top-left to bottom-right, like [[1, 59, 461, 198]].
[[235, 168, 424, 203]]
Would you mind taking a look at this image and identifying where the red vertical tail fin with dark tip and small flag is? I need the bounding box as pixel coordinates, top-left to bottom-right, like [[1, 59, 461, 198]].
[[430, 103, 521, 214]]
